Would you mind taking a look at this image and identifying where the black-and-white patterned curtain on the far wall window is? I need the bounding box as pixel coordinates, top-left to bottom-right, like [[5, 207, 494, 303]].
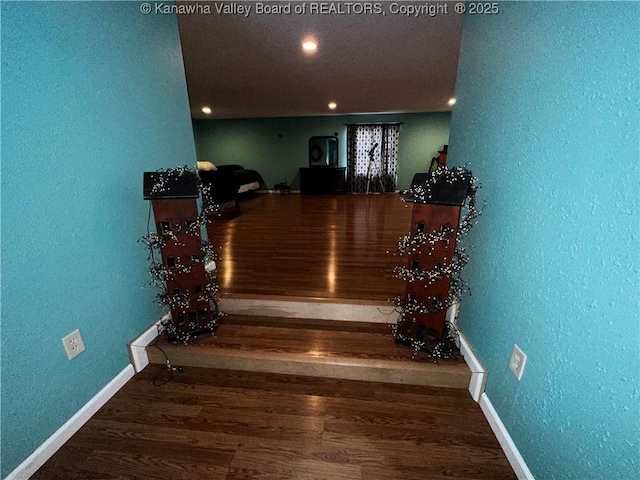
[[347, 123, 400, 193]]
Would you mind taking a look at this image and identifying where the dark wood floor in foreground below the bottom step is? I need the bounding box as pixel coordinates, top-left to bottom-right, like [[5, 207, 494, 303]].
[[32, 366, 515, 480]]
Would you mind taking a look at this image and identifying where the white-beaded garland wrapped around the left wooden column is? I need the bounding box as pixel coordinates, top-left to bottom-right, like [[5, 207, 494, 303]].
[[138, 165, 224, 344]]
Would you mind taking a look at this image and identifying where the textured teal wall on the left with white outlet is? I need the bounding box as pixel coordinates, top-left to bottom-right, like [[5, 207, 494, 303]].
[[1, 2, 196, 478]]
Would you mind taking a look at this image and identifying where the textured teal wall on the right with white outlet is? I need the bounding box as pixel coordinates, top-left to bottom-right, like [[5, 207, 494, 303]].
[[449, 2, 640, 480]]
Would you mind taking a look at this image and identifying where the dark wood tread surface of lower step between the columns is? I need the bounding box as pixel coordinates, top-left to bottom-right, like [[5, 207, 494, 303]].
[[151, 315, 468, 372]]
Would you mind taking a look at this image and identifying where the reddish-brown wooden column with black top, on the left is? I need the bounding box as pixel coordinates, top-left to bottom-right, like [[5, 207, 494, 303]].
[[144, 172, 219, 342]]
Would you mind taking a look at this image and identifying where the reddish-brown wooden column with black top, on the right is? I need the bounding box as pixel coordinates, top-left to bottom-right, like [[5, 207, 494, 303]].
[[395, 172, 471, 351]]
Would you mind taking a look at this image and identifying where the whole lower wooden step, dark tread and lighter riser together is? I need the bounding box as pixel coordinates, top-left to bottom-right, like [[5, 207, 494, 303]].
[[147, 315, 471, 389]]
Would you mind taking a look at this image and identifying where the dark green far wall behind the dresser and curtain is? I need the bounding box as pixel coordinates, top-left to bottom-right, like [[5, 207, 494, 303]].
[[194, 112, 451, 189]]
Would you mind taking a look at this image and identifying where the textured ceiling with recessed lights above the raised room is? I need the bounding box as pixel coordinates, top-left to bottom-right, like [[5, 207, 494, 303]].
[[178, 2, 462, 119]]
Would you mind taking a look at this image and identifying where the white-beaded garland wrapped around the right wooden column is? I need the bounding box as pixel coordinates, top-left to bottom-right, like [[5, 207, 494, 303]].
[[392, 166, 482, 358]]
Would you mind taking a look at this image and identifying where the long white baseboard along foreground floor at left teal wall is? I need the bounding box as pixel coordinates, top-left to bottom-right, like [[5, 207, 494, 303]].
[[5, 364, 135, 480]]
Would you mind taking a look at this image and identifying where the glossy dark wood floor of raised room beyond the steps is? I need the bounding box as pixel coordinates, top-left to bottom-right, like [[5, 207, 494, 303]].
[[208, 194, 411, 302]]
